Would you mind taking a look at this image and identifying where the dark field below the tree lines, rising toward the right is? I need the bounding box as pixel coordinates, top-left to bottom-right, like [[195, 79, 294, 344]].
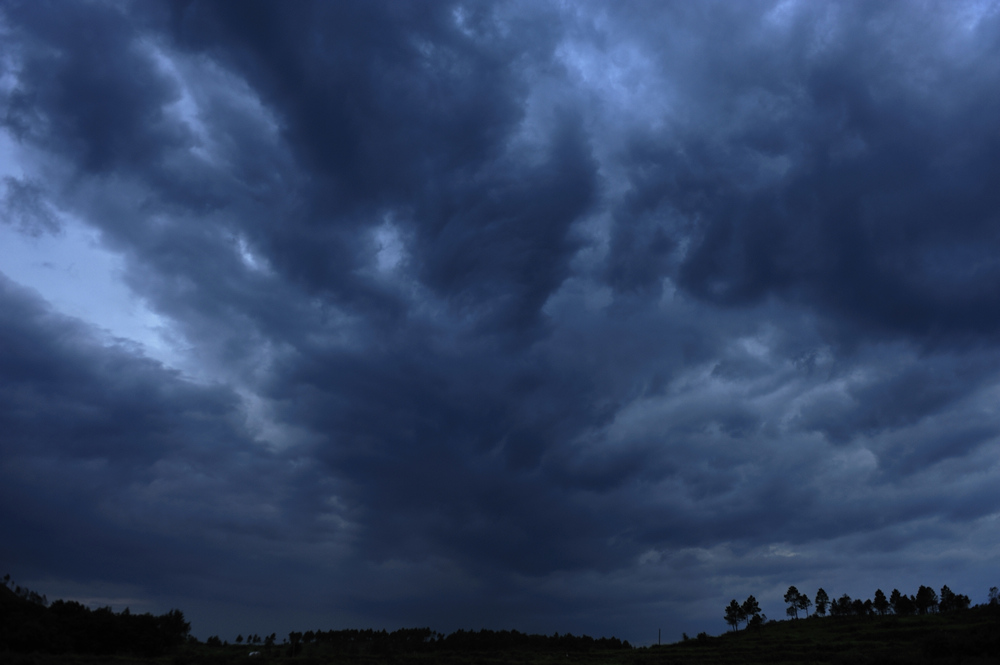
[[7, 606, 1000, 665]]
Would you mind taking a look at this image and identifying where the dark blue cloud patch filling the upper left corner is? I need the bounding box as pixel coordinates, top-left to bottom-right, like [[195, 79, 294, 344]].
[[4, 2, 183, 173]]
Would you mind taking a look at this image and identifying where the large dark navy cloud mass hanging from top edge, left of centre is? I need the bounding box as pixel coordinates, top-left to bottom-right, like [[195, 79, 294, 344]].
[[164, 3, 595, 326]]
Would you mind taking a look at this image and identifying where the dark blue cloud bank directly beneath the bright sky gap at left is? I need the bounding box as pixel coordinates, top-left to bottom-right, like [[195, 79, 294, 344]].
[[0, 272, 368, 616]]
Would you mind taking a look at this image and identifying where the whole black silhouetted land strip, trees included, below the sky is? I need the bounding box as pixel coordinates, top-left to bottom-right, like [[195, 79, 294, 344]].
[[0, 576, 1000, 665]]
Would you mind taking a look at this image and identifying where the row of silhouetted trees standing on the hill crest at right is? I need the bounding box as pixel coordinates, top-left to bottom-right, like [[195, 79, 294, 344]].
[[725, 585, 984, 631]]
